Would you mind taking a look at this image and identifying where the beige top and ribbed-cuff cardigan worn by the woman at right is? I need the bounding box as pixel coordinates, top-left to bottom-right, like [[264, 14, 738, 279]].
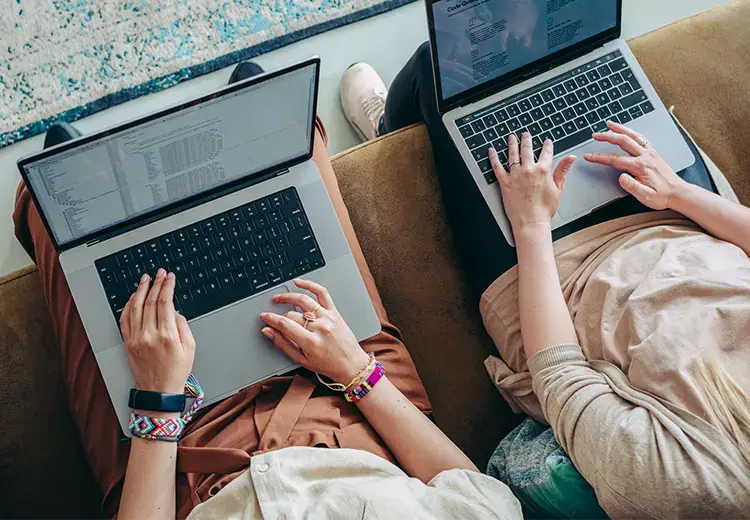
[[481, 144, 750, 519]]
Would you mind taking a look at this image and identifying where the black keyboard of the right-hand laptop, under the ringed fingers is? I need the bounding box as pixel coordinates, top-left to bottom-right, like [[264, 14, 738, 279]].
[[456, 51, 654, 184]]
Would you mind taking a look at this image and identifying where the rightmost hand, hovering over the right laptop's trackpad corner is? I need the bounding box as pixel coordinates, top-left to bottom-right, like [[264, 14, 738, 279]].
[[585, 121, 687, 210]]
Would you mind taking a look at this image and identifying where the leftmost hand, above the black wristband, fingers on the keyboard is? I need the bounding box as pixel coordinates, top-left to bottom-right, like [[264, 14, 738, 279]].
[[120, 269, 195, 394]]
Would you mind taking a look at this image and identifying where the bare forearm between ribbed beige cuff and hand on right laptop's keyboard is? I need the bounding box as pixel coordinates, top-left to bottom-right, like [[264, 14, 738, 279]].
[[515, 224, 578, 359]]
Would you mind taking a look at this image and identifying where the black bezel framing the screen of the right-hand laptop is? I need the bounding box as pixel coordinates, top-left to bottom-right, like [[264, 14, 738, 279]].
[[425, 0, 622, 116]]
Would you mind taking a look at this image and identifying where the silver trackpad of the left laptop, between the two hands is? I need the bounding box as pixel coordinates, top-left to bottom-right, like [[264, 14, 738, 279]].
[[190, 285, 296, 399]]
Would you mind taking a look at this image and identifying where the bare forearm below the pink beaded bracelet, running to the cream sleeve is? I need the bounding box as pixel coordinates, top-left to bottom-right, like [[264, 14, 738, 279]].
[[357, 377, 478, 483]]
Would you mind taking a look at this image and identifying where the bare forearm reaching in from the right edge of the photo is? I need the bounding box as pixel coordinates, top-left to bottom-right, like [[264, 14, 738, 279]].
[[670, 183, 750, 255]]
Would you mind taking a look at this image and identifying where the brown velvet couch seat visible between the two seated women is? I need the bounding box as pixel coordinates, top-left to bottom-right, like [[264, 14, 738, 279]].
[[333, 126, 519, 469]]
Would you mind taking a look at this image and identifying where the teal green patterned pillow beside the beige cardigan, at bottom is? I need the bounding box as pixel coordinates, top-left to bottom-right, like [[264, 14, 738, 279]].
[[487, 418, 608, 519]]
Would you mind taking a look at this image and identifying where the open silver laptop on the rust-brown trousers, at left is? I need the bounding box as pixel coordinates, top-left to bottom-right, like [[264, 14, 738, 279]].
[[18, 58, 380, 434]]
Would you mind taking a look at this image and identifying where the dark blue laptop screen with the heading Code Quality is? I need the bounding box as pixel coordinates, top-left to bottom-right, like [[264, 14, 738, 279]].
[[428, 0, 617, 100]]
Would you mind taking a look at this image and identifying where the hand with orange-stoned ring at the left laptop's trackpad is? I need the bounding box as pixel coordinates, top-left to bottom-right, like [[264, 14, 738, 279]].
[[260, 280, 369, 385]]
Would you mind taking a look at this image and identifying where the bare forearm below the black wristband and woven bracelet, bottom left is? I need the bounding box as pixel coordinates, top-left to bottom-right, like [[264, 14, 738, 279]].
[[117, 413, 177, 520]]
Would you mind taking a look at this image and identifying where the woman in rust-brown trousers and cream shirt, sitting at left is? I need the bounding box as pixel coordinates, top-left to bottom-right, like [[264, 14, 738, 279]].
[[13, 63, 521, 520]]
